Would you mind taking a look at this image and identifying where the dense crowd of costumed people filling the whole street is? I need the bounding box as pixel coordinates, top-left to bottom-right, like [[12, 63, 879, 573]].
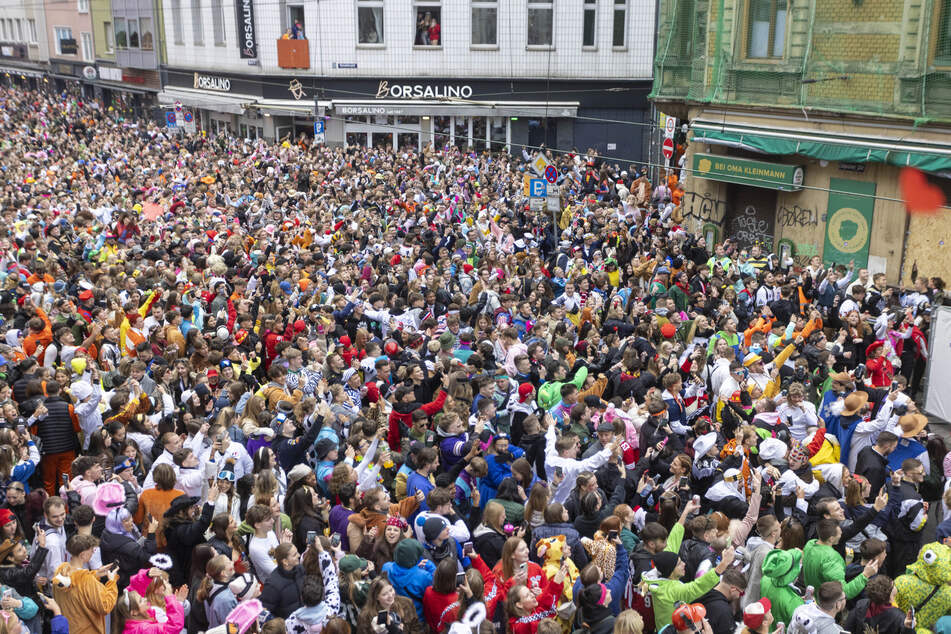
[[0, 84, 951, 634]]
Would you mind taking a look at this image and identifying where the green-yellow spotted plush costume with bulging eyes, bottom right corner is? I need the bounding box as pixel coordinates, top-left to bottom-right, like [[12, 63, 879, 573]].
[[895, 542, 951, 634]]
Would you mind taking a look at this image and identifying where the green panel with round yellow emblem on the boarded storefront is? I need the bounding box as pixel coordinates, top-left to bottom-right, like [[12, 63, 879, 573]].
[[822, 178, 875, 270]]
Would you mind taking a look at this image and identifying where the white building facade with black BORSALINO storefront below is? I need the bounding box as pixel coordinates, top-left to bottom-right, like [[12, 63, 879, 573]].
[[160, 0, 655, 160]]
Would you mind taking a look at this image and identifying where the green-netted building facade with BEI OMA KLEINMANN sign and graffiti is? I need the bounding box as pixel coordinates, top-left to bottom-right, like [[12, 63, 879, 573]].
[[652, 0, 951, 284]]
